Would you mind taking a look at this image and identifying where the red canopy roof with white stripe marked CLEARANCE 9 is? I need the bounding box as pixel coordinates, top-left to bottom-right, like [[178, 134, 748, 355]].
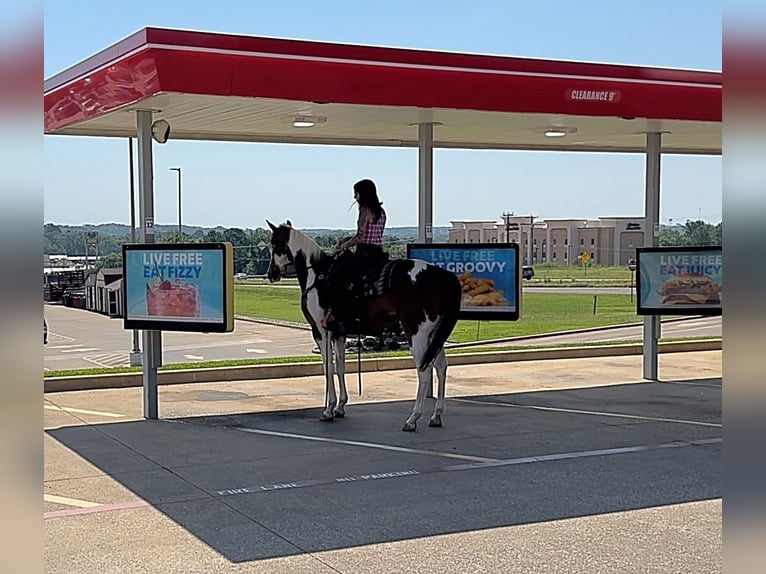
[[44, 28, 722, 155]]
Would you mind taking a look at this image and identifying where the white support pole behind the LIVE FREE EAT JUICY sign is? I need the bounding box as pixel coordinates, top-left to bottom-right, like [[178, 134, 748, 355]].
[[643, 133, 662, 381]]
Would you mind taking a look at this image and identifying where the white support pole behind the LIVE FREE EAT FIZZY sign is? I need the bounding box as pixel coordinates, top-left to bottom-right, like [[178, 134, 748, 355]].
[[136, 110, 162, 419]]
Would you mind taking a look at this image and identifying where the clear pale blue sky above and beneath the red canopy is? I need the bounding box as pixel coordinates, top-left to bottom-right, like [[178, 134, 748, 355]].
[[44, 0, 722, 228]]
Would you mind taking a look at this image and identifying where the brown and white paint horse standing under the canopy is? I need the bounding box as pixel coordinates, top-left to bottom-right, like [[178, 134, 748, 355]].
[[266, 221, 461, 431]]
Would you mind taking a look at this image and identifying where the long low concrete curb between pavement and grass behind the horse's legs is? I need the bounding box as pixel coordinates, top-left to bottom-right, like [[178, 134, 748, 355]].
[[43, 339, 723, 393]]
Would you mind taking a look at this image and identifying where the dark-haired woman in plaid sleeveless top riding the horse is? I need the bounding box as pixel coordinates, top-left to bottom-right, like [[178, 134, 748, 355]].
[[322, 179, 386, 327]]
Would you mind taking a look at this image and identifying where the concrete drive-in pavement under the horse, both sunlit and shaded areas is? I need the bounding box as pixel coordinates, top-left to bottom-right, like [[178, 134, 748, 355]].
[[44, 351, 722, 574]]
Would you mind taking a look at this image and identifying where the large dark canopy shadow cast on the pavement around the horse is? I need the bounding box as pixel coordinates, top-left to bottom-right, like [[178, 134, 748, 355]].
[[47, 379, 721, 562]]
